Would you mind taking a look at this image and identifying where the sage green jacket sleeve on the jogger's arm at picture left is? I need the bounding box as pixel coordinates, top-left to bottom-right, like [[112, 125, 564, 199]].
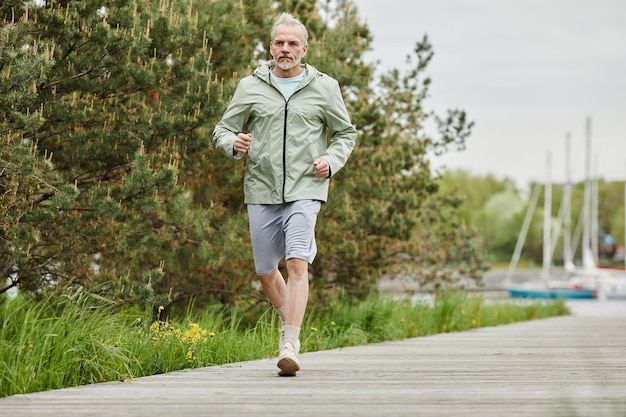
[[213, 80, 249, 159]]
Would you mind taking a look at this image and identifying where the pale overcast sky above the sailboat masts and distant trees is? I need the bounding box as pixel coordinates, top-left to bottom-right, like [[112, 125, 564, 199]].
[[354, 0, 626, 186]]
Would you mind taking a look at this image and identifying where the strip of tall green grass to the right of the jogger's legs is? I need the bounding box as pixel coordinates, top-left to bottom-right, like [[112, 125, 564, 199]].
[[301, 291, 569, 351]]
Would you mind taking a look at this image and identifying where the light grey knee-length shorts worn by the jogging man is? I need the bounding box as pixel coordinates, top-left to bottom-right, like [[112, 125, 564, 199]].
[[248, 200, 322, 275]]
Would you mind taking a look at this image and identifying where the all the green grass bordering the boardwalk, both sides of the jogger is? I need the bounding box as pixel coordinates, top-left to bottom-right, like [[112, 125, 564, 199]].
[[0, 292, 568, 397]]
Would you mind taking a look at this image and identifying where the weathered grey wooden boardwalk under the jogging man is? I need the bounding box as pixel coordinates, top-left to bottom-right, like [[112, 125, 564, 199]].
[[0, 301, 626, 417]]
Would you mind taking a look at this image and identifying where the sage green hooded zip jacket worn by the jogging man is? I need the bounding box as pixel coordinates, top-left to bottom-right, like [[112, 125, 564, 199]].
[[213, 61, 356, 204]]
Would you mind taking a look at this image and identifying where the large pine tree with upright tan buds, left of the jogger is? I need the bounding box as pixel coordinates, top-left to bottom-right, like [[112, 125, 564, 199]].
[[0, 0, 272, 303]]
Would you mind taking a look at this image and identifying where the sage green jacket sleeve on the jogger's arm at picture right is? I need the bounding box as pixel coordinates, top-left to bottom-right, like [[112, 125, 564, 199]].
[[321, 79, 357, 176]]
